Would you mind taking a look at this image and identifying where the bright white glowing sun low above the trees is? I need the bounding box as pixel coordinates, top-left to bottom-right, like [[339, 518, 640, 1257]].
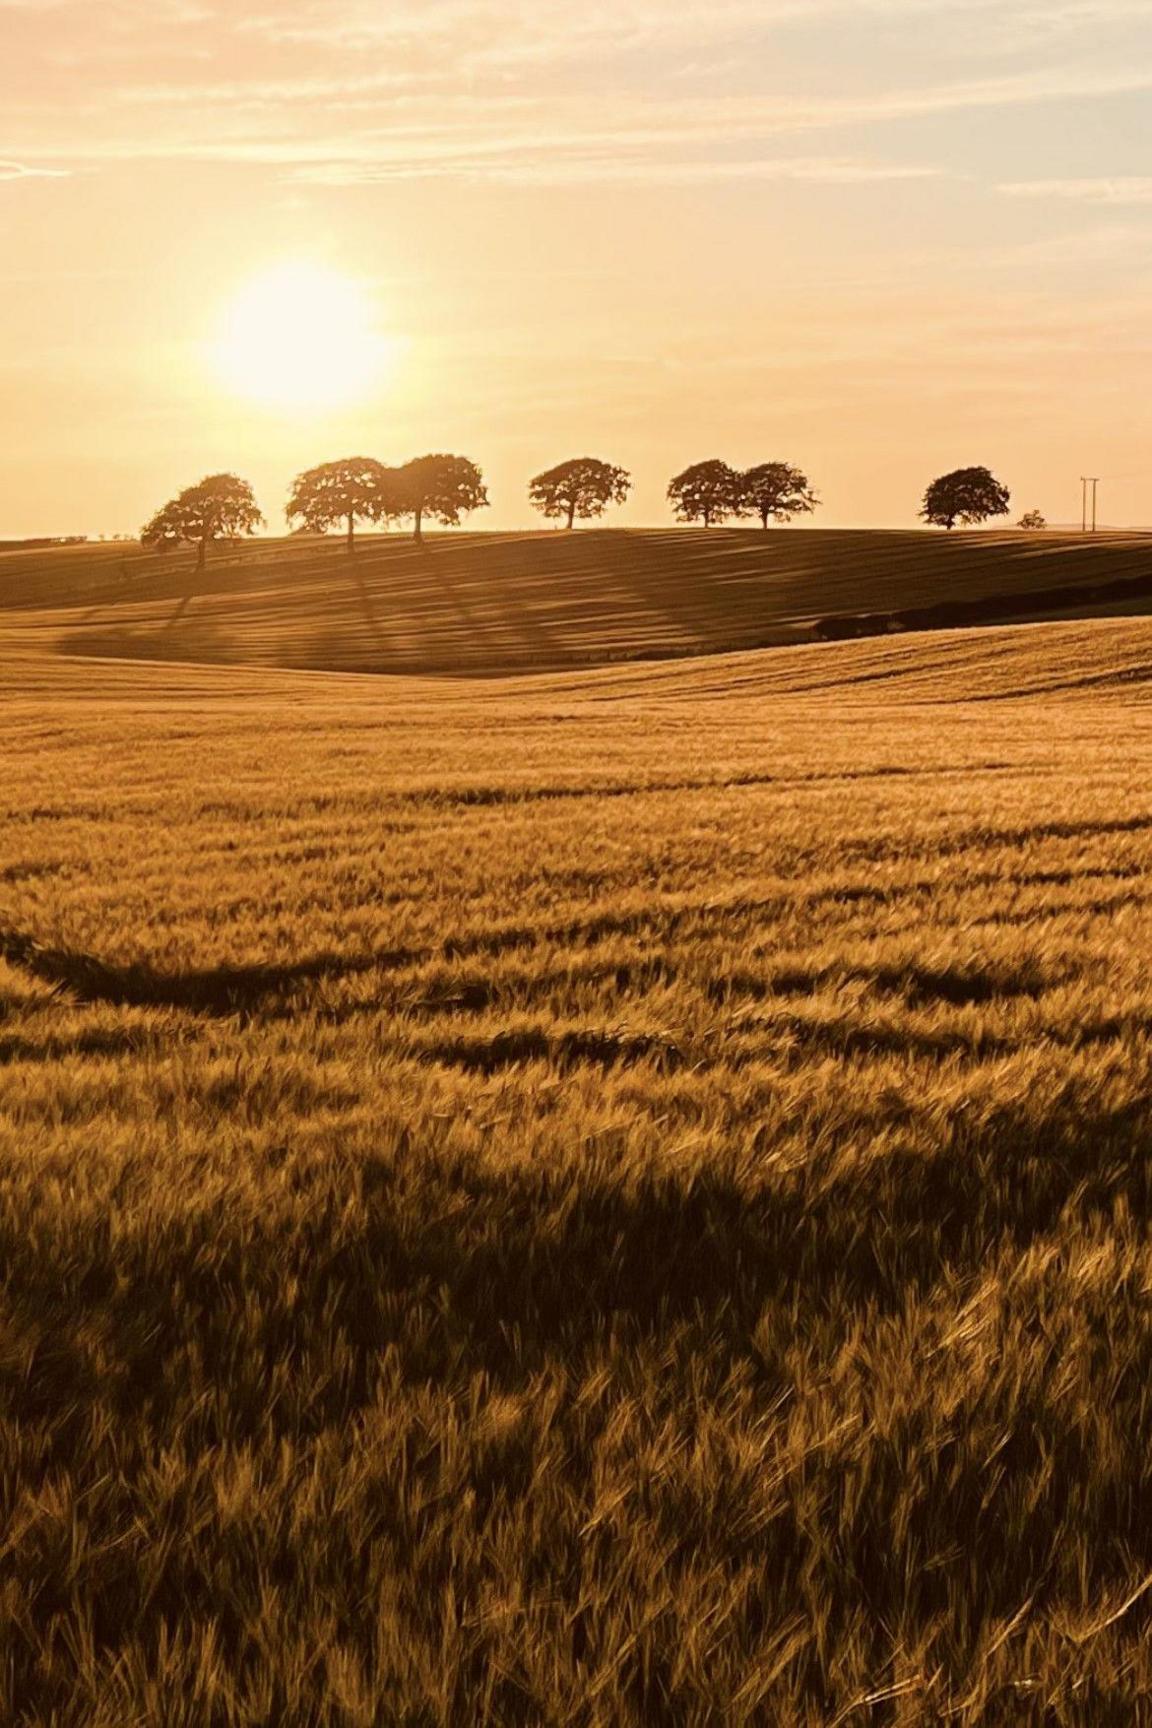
[[214, 263, 396, 410]]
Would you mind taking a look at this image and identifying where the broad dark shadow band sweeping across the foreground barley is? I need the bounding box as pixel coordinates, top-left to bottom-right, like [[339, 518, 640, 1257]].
[[0, 1064, 1152, 1416]]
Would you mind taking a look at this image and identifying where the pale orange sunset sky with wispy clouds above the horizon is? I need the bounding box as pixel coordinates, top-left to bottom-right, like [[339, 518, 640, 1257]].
[[0, 0, 1152, 536]]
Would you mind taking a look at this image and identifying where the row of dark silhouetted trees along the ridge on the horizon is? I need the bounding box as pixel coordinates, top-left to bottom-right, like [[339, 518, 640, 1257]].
[[140, 453, 1047, 565]]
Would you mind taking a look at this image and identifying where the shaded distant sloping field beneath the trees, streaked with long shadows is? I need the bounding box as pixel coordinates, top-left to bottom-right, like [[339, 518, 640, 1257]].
[[0, 529, 1152, 674]]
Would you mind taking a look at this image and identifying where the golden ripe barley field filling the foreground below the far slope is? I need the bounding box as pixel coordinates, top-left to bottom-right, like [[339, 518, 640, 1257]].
[[0, 628, 1152, 1728]]
